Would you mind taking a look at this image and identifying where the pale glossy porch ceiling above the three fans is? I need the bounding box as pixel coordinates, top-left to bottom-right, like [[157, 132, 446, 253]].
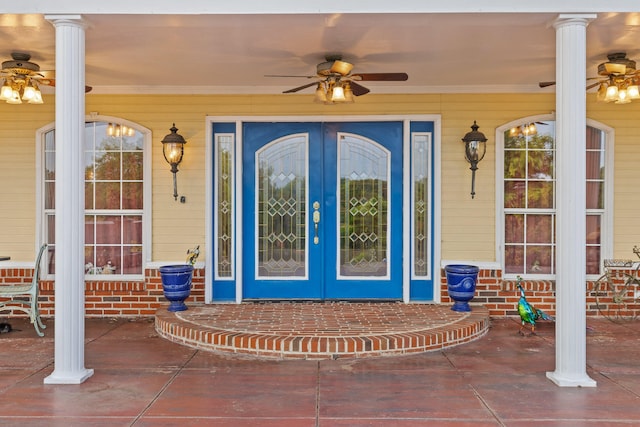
[[0, 13, 640, 94]]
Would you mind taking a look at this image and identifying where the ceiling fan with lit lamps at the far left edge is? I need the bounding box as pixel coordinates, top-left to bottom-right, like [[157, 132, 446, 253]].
[[0, 52, 92, 104]]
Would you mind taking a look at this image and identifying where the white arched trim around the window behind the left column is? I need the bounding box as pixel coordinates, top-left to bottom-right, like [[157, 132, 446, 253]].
[[35, 114, 153, 281]]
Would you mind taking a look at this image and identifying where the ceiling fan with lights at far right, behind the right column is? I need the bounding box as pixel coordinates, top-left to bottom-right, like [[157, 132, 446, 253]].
[[539, 52, 640, 104]]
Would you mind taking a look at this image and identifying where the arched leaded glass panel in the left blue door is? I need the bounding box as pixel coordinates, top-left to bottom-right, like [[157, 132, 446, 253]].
[[256, 135, 308, 278]]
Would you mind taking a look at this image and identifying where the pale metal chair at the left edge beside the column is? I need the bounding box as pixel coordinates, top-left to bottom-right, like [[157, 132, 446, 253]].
[[0, 244, 47, 337]]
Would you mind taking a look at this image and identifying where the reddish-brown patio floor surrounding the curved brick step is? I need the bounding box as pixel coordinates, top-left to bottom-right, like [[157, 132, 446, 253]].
[[0, 318, 640, 427]]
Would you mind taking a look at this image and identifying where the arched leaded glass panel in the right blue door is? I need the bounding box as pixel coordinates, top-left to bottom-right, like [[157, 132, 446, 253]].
[[338, 134, 390, 277]]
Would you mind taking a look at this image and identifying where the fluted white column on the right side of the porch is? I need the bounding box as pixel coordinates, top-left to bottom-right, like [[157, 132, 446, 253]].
[[547, 14, 596, 387]]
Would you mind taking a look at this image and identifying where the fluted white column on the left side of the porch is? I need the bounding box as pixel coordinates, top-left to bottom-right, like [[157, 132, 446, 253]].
[[44, 15, 93, 384]]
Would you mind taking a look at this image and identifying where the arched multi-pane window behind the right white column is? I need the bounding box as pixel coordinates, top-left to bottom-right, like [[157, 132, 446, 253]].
[[496, 118, 613, 279]]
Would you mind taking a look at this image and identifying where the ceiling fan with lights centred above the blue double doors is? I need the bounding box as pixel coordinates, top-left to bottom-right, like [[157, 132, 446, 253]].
[[265, 55, 409, 104]]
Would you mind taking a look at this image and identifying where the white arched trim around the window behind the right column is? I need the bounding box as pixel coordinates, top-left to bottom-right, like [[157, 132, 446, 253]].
[[495, 113, 615, 280]]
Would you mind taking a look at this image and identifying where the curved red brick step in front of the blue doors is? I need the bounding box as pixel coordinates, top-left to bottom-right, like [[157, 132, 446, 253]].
[[155, 302, 489, 359]]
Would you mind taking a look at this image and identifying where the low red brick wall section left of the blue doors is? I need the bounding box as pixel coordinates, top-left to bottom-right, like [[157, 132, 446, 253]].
[[0, 268, 204, 317]]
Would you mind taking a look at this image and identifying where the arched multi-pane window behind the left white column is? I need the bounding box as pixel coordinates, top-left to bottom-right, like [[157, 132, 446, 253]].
[[40, 120, 150, 280]]
